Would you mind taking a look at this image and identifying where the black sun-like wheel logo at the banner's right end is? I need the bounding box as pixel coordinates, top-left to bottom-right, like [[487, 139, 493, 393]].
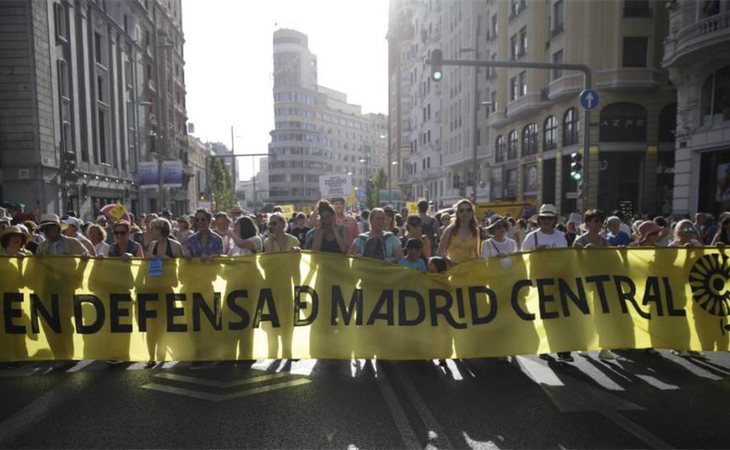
[[689, 254, 730, 317]]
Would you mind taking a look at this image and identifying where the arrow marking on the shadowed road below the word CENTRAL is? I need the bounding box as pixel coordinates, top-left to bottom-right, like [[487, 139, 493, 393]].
[[516, 356, 674, 449]]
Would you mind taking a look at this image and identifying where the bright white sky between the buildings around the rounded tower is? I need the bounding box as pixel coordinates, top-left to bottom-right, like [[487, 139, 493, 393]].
[[182, 0, 388, 180]]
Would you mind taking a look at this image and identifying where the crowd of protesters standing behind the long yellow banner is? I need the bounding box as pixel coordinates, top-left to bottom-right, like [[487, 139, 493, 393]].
[[0, 198, 730, 361]]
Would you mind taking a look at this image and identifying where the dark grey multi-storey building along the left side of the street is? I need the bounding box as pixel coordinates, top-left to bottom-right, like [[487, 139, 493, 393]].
[[0, 0, 189, 219]]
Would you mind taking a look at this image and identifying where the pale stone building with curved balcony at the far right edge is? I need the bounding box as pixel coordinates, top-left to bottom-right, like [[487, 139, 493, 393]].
[[663, 0, 730, 218]]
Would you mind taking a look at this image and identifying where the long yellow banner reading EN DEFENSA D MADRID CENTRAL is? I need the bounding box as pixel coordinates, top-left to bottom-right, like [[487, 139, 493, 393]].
[[0, 248, 730, 361]]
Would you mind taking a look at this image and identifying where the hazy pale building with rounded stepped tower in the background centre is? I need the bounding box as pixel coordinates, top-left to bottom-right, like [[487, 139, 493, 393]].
[[266, 29, 387, 207]]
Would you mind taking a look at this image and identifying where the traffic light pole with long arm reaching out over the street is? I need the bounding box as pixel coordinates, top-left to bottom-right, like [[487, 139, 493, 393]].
[[425, 56, 593, 206]]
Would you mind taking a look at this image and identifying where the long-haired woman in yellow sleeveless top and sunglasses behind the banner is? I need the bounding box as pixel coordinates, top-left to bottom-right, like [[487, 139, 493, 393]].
[[437, 199, 480, 265]]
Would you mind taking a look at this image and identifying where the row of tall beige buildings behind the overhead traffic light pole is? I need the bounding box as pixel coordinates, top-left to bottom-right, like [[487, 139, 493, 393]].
[[391, 0, 676, 214]]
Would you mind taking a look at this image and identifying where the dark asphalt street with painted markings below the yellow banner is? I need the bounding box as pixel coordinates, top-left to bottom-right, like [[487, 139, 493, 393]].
[[0, 350, 730, 449]]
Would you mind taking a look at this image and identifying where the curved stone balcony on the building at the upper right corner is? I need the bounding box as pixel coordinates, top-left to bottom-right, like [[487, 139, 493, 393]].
[[664, 11, 730, 66]]
